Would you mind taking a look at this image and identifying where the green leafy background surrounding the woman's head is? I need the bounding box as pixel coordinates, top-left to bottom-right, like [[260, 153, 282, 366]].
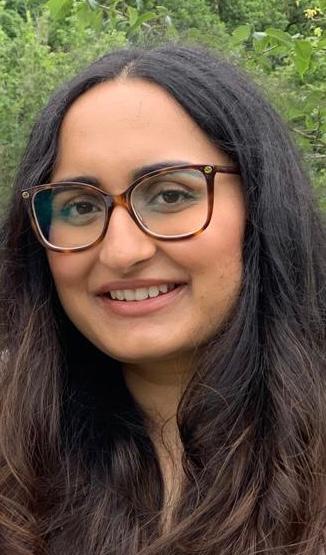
[[0, 0, 326, 211]]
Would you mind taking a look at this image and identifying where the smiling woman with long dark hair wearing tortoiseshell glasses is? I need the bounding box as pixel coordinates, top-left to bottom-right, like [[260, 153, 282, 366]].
[[0, 45, 326, 555]]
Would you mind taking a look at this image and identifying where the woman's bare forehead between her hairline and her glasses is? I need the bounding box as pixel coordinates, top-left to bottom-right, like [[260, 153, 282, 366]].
[[52, 79, 233, 192]]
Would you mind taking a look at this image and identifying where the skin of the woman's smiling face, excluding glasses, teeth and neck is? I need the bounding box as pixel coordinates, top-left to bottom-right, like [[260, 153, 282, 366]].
[[48, 79, 245, 374]]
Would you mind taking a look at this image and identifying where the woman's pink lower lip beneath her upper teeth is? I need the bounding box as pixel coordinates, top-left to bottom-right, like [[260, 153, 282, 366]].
[[98, 282, 187, 316]]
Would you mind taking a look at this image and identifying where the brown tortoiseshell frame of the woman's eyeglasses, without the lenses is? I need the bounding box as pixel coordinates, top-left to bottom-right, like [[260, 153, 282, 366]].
[[21, 164, 240, 253]]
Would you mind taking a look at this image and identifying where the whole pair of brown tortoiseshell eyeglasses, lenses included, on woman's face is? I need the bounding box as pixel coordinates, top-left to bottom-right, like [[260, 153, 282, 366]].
[[21, 165, 240, 252]]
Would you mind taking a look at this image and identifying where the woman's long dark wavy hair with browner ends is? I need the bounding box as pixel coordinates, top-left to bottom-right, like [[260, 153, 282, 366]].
[[0, 45, 326, 555]]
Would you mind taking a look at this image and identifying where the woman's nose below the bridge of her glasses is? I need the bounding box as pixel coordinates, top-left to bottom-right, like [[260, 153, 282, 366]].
[[99, 206, 157, 274]]
